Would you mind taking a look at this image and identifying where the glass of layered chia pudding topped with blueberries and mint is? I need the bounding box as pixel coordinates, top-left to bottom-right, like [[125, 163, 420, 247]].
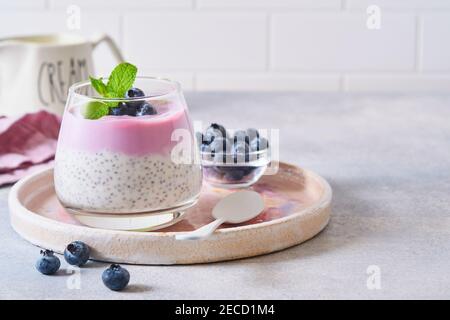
[[54, 74, 202, 228]]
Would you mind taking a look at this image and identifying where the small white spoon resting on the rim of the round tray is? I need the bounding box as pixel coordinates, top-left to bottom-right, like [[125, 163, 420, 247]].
[[175, 190, 264, 240]]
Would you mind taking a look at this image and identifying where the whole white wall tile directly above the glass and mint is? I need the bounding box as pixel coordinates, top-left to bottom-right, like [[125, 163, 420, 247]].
[[124, 13, 266, 71]]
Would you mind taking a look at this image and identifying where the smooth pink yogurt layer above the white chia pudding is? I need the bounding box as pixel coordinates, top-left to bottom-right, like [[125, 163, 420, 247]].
[[58, 104, 192, 156]]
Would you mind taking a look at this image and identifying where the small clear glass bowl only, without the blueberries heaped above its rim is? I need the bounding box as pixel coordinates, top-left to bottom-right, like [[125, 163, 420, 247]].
[[200, 149, 270, 189]]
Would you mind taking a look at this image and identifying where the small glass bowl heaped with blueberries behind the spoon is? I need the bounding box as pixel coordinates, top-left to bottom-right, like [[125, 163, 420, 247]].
[[196, 123, 270, 189]]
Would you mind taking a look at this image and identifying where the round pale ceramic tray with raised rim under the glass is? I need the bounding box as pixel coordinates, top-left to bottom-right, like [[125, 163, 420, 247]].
[[9, 163, 332, 264]]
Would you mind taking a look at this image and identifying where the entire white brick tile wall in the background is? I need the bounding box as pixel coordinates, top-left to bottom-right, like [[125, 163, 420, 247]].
[[0, 0, 450, 92]]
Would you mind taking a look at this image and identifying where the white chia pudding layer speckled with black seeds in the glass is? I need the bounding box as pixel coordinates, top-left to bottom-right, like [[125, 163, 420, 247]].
[[54, 149, 202, 213]]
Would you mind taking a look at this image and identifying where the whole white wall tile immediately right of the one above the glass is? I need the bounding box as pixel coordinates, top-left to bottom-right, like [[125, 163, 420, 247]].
[[271, 13, 415, 71]]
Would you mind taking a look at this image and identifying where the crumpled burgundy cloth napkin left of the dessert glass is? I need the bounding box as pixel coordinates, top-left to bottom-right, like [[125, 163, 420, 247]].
[[0, 111, 61, 186]]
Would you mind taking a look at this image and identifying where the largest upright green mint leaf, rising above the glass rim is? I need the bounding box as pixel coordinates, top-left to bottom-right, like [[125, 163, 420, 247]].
[[106, 62, 137, 98]]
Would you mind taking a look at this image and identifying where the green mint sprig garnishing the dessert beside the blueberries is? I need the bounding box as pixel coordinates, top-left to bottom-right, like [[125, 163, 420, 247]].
[[84, 62, 137, 120]]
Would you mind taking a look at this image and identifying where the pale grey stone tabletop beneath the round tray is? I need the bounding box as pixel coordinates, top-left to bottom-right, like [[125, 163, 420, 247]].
[[0, 93, 450, 300]]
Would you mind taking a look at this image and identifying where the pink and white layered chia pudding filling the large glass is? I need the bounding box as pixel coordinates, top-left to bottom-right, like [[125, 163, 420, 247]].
[[54, 98, 202, 213]]
